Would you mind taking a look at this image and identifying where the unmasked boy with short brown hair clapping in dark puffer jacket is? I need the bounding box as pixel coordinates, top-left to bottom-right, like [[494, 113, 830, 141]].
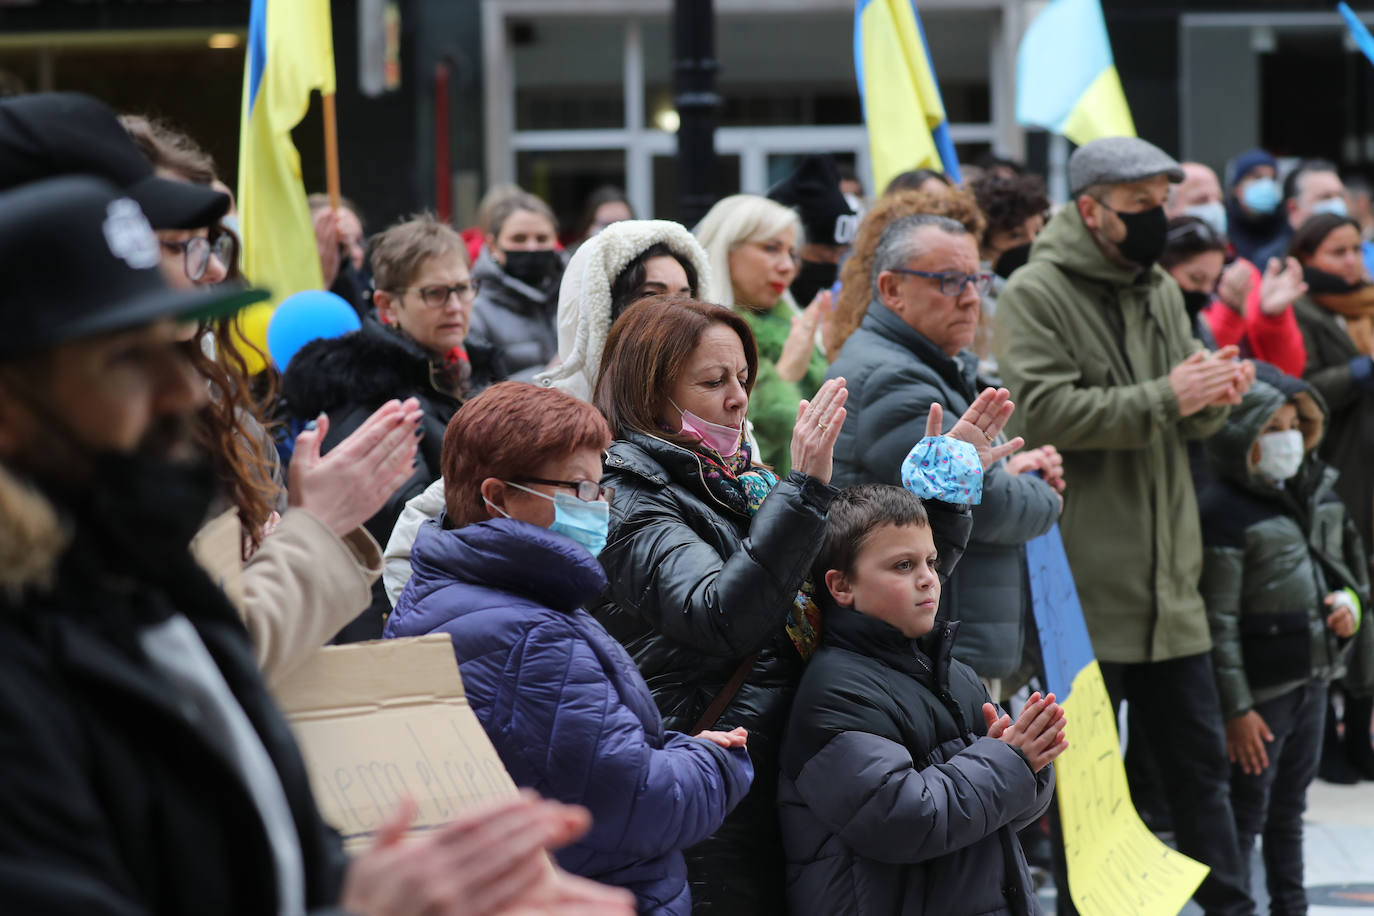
[[778, 485, 1066, 916]]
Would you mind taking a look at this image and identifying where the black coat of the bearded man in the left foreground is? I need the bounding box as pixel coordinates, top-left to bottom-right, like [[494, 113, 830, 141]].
[[0, 505, 346, 916]]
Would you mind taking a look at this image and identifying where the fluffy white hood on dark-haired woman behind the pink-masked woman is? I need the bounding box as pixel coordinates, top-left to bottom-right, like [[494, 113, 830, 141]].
[[534, 220, 713, 401]]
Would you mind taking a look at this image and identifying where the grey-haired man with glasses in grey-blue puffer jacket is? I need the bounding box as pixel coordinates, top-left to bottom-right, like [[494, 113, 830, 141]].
[[830, 214, 1063, 699]]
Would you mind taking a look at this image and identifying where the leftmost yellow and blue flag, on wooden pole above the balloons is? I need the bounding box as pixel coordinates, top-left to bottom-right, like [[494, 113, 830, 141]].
[[238, 0, 334, 369]]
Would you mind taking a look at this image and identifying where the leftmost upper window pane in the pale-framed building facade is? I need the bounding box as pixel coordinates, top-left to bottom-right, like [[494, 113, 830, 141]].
[[507, 16, 625, 130]]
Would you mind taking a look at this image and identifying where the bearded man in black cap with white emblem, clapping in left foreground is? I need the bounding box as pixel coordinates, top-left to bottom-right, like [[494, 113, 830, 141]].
[[0, 177, 628, 916]]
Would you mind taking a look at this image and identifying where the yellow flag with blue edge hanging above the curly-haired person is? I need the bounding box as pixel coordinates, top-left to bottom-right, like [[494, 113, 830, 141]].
[[855, 0, 960, 192]]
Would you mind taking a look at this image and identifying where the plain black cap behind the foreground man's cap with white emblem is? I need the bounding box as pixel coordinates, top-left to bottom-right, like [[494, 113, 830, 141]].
[[0, 92, 229, 229]]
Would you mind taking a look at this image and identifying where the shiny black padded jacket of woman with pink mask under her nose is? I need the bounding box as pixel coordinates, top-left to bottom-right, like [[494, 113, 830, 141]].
[[595, 433, 970, 915]]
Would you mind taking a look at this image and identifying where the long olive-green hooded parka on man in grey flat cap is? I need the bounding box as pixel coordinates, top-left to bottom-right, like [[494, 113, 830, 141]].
[[996, 206, 1226, 662]]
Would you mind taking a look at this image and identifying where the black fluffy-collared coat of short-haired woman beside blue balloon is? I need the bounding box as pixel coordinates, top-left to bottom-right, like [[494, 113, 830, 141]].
[[282, 319, 506, 643]]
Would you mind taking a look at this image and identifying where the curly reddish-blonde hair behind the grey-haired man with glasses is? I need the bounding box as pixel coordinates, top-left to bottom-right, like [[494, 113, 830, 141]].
[[822, 187, 985, 363]]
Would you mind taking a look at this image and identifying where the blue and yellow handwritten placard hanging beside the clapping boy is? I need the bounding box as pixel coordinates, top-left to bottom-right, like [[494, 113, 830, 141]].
[[1026, 526, 1208, 916]]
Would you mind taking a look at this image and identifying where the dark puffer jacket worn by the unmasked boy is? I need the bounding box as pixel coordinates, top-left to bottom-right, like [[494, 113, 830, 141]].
[[778, 608, 1054, 916]]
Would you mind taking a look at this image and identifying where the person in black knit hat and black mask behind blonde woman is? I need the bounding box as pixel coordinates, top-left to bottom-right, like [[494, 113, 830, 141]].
[[768, 155, 859, 308]]
